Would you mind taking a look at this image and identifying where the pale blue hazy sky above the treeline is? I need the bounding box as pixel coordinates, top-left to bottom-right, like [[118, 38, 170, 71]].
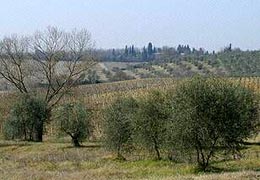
[[0, 0, 260, 50]]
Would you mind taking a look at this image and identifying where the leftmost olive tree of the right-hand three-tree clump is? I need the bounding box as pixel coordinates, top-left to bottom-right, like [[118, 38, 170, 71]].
[[103, 98, 137, 159]]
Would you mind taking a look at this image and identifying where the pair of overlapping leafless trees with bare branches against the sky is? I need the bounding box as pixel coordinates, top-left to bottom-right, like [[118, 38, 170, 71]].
[[0, 27, 96, 141]]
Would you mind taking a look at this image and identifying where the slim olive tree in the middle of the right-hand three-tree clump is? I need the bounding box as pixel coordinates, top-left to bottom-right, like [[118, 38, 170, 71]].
[[135, 91, 170, 159]]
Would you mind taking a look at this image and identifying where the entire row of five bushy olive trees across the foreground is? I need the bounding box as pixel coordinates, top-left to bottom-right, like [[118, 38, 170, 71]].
[[4, 77, 260, 171]]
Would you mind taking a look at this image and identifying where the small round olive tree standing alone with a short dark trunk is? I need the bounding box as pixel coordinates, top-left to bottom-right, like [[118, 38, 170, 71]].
[[56, 103, 91, 147]]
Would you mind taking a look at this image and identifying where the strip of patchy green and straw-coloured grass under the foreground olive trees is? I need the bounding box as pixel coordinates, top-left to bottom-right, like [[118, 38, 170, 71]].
[[0, 140, 260, 180]]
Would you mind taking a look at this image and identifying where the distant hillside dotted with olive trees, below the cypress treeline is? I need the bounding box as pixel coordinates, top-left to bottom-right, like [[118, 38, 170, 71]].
[[90, 50, 260, 82]]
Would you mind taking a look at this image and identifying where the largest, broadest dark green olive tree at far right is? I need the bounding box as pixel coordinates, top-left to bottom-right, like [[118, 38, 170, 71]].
[[168, 77, 259, 171]]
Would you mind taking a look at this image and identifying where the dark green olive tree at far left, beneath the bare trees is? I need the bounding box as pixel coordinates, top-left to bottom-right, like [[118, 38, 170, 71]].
[[4, 95, 47, 142]]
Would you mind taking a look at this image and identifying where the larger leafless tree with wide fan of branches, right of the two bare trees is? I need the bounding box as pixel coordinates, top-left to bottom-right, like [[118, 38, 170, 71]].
[[32, 27, 96, 109]]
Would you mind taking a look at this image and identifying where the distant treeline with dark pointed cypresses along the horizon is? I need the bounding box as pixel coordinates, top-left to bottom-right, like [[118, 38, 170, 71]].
[[97, 43, 260, 76]]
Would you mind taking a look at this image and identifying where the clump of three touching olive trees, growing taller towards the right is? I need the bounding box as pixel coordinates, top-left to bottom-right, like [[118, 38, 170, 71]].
[[104, 78, 259, 171]]
